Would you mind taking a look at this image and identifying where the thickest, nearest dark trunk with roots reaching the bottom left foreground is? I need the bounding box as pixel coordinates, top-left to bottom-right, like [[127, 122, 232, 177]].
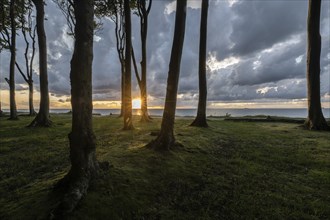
[[55, 0, 99, 217]]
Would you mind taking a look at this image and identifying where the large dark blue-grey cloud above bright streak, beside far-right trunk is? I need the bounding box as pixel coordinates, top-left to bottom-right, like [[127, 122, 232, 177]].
[[230, 1, 307, 56]]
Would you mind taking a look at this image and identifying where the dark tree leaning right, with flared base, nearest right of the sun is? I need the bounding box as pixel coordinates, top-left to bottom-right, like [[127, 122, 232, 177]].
[[147, 0, 187, 150]]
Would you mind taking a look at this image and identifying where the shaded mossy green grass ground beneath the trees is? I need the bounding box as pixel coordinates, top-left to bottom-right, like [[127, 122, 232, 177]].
[[0, 115, 330, 219]]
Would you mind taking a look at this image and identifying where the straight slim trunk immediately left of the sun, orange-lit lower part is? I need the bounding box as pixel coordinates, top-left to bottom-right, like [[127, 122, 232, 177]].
[[123, 0, 133, 130]]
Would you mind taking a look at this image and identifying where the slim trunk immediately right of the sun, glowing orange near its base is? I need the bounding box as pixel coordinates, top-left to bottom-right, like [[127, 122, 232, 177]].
[[140, 0, 151, 122]]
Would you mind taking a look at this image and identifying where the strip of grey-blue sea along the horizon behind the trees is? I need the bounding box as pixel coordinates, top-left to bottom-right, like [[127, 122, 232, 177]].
[[4, 108, 330, 118]]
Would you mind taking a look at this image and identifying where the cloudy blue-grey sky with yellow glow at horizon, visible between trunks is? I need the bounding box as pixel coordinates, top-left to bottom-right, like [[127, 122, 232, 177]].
[[0, 0, 330, 109]]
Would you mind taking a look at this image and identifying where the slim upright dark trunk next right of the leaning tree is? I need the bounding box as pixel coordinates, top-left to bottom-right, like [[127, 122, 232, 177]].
[[191, 0, 209, 127]]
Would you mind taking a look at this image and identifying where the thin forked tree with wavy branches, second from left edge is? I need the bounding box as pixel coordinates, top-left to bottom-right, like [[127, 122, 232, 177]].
[[15, 1, 36, 116]]
